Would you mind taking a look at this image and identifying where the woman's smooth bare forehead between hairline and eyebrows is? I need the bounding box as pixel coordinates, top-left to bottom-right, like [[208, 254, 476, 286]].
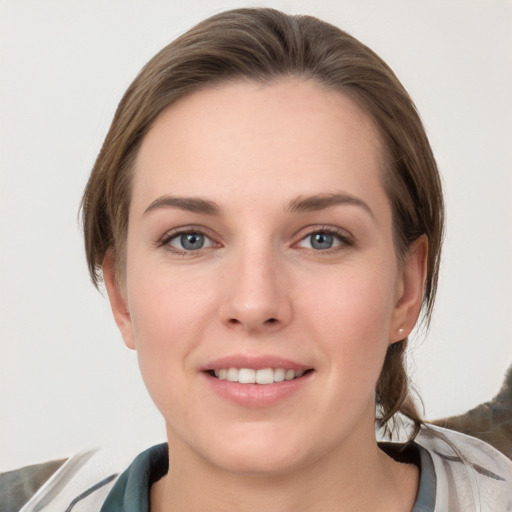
[[132, 79, 382, 214]]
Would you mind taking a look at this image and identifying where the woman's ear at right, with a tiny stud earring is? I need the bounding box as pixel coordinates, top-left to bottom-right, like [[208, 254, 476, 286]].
[[389, 235, 428, 343]]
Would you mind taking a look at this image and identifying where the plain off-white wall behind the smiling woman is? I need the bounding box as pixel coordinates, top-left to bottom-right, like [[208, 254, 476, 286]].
[[0, 0, 512, 471]]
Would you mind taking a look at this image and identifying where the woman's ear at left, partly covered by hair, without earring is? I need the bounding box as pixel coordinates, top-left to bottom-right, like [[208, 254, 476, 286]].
[[102, 250, 135, 350]]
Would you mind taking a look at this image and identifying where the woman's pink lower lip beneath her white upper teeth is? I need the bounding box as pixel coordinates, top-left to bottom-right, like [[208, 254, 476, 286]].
[[203, 372, 313, 408]]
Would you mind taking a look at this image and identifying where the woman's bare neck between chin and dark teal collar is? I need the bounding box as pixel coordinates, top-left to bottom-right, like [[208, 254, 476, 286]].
[[151, 428, 418, 512]]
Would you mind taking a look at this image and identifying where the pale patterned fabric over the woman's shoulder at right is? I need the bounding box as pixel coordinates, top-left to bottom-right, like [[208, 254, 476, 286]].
[[415, 425, 512, 512]]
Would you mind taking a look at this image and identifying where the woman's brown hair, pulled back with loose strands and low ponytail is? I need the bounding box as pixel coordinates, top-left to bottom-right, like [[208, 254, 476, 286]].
[[81, 9, 444, 432]]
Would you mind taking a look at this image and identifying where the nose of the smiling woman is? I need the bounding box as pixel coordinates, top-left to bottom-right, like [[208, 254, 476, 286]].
[[221, 248, 292, 333]]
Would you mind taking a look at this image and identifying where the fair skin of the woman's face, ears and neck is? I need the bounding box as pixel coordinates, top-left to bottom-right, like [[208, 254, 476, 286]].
[[103, 79, 427, 512]]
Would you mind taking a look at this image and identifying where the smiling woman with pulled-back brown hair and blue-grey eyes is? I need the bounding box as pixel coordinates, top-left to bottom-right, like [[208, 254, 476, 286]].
[[8, 9, 512, 512]]
